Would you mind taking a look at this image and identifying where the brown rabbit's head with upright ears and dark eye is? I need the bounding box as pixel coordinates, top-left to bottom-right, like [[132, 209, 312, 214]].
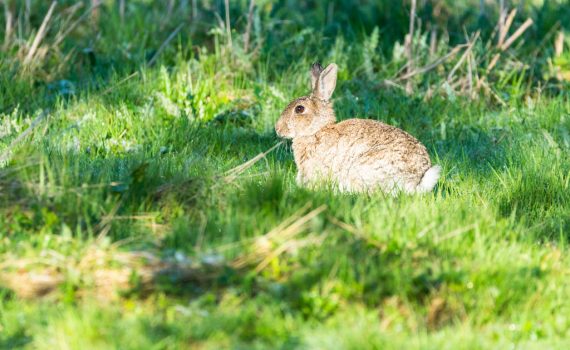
[[275, 63, 338, 139]]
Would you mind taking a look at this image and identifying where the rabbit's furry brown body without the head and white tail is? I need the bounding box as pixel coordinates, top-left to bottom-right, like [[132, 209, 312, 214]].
[[293, 119, 431, 192]]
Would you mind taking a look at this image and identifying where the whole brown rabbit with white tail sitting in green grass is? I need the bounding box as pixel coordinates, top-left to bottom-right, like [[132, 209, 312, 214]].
[[275, 63, 441, 193]]
